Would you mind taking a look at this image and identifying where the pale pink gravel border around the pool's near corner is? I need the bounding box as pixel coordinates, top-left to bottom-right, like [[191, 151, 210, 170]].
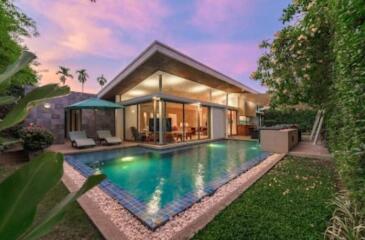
[[64, 154, 285, 240]]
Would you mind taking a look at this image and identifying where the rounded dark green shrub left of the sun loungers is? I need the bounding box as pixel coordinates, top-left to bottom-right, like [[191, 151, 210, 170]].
[[19, 125, 54, 151]]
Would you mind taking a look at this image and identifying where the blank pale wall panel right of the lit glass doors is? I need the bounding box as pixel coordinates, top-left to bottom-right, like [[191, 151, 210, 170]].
[[210, 107, 226, 139]]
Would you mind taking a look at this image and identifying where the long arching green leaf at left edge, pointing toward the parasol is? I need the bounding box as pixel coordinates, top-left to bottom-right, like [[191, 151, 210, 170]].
[[0, 84, 70, 131]]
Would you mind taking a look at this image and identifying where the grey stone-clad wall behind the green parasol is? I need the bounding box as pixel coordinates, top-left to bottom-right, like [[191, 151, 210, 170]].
[[24, 92, 115, 144]]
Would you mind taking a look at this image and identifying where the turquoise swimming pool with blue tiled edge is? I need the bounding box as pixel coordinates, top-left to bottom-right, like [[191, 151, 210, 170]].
[[65, 140, 269, 229]]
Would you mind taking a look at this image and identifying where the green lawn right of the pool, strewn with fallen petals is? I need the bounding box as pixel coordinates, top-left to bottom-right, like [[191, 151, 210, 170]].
[[194, 157, 336, 240]]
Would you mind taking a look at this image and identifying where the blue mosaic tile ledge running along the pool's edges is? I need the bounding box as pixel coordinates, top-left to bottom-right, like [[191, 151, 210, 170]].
[[65, 142, 271, 230]]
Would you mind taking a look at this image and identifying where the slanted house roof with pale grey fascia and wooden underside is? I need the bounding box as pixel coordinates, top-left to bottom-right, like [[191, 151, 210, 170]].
[[98, 41, 258, 100]]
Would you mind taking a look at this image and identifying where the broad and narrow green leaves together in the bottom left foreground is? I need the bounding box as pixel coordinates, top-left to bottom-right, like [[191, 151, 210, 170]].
[[0, 152, 105, 239]]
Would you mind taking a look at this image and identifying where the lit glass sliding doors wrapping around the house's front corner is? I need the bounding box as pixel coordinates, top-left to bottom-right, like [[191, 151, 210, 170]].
[[124, 99, 210, 144]]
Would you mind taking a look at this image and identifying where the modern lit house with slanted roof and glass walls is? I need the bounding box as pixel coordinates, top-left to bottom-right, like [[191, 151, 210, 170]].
[[98, 41, 266, 144]]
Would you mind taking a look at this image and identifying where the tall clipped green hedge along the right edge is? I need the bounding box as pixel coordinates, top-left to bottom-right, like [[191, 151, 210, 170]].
[[326, 0, 365, 208]]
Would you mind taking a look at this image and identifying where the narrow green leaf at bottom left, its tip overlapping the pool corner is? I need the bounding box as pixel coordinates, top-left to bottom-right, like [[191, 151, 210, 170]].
[[20, 174, 105, 240]]
